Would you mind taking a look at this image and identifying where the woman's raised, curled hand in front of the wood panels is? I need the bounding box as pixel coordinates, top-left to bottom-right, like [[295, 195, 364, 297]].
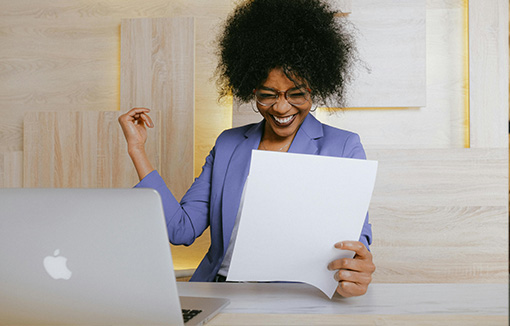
[[119, 108, 154, 151]]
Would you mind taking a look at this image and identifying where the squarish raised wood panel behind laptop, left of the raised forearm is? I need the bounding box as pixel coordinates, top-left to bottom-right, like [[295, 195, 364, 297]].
[[23, 111, 160, 188]]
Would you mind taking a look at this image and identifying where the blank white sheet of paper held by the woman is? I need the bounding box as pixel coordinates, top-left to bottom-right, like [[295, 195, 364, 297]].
[[227, 150, 377, 298]]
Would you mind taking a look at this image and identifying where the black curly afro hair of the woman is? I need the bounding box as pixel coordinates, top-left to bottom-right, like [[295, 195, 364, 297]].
[[216, 0, 357, 106]]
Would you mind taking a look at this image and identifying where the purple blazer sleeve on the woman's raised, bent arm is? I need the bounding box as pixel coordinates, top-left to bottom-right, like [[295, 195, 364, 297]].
[[135, 148, 215, 246]]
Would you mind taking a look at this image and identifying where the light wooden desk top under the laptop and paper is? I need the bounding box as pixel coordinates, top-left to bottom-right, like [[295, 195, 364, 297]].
[[178, 282, 508, 326]]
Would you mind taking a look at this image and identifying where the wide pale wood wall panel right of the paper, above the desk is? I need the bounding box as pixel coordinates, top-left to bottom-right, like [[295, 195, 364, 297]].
[[368, 149, 508, 283]]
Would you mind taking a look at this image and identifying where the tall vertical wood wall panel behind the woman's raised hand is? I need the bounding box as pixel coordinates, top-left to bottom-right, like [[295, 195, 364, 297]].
[[121, 17, 194, 199]]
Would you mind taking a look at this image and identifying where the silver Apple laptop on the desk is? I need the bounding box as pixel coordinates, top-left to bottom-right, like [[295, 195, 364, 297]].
[[0, 189, 229, 325]]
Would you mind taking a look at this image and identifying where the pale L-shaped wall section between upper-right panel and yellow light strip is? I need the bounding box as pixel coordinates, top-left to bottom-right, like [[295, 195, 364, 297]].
[[317, 0, 467, 149]]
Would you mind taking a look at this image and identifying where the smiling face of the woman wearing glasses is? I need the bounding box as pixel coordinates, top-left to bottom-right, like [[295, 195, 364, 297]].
[[257, 68, 312, 141]]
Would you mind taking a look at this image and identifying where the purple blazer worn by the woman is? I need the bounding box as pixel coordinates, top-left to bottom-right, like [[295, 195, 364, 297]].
[[135, 114, 372, 282]]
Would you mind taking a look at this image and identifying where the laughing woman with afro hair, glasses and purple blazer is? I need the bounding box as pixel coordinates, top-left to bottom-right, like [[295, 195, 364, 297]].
[[119, 0, 375, 297]]
